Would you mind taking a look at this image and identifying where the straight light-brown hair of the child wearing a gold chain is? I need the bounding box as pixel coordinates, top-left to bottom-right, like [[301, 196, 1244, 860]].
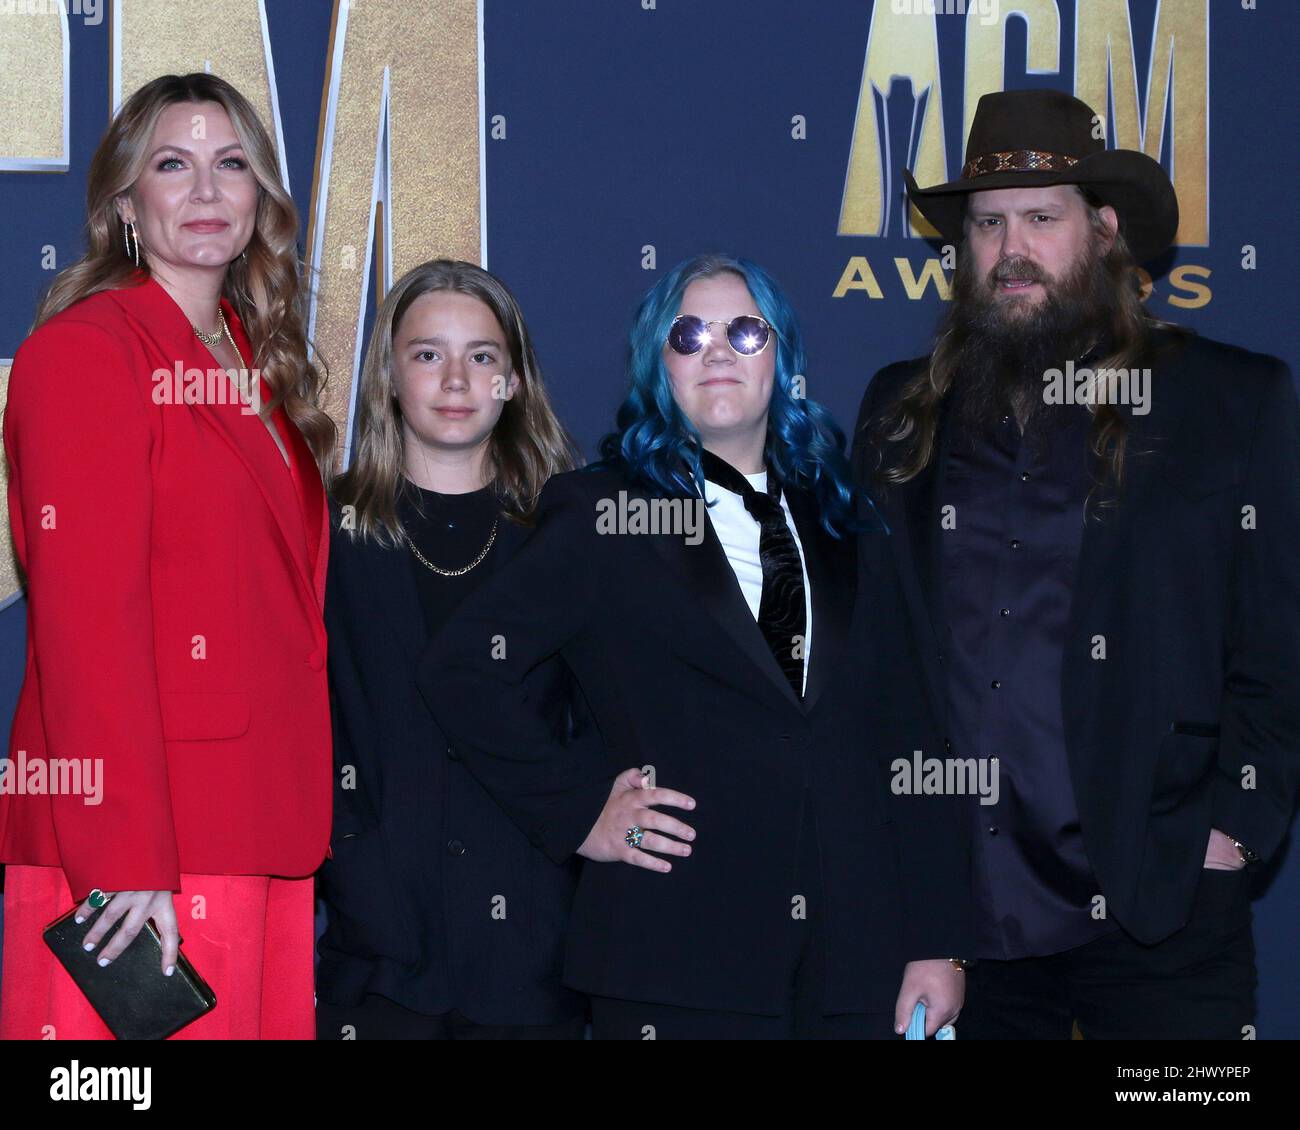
[[333, 259, 577, 546]]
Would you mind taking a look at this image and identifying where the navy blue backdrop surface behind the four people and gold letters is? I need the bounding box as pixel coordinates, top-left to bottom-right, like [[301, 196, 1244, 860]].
[[0, 0, 1300, 1039]]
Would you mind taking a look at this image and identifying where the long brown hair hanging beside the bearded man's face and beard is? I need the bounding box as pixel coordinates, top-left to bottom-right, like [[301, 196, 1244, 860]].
[[868, 186, 1182, 490]]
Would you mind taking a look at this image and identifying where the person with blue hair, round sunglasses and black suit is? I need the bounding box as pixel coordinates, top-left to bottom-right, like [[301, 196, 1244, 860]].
[[419, 255, 970, 1039]]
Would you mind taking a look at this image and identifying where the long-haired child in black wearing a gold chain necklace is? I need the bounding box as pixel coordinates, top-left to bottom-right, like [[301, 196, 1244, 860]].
[[317, 260, 585, 1039]]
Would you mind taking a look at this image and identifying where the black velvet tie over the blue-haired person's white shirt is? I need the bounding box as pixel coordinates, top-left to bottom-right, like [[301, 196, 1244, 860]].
[[699, 451, 807, 698]]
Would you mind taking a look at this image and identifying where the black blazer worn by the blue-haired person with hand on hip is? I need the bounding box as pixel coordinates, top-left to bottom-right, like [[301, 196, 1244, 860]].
[[420, 466, 970, 1014]]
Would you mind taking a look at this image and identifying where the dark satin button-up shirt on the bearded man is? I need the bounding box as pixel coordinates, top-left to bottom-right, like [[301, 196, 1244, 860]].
[[940, 406, 1115, 960]]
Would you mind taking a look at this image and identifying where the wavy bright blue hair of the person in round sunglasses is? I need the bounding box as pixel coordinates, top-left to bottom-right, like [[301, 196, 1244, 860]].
[[599, 254, 858, 537]]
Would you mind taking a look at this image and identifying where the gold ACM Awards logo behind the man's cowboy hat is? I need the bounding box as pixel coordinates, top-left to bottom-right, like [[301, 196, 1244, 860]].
[[832, 0, 1213, 309]]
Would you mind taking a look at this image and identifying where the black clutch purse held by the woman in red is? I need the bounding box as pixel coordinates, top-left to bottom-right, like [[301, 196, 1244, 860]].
[[44, 908, 217, 1040]]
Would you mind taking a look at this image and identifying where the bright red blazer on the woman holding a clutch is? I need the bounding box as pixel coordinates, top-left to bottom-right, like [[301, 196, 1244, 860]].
[[0, 280, 332, 899]]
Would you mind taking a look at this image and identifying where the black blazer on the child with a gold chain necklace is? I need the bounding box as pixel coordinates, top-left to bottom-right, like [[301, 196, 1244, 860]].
[[317, 499, 585, 1025]]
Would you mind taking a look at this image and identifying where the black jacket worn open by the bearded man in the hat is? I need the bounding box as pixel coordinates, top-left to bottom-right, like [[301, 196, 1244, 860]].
[[853, 332, 1300, 944]]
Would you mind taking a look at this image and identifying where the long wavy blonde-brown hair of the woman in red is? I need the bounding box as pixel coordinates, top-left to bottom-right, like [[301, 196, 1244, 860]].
[[35, 73, 335, 477]]
